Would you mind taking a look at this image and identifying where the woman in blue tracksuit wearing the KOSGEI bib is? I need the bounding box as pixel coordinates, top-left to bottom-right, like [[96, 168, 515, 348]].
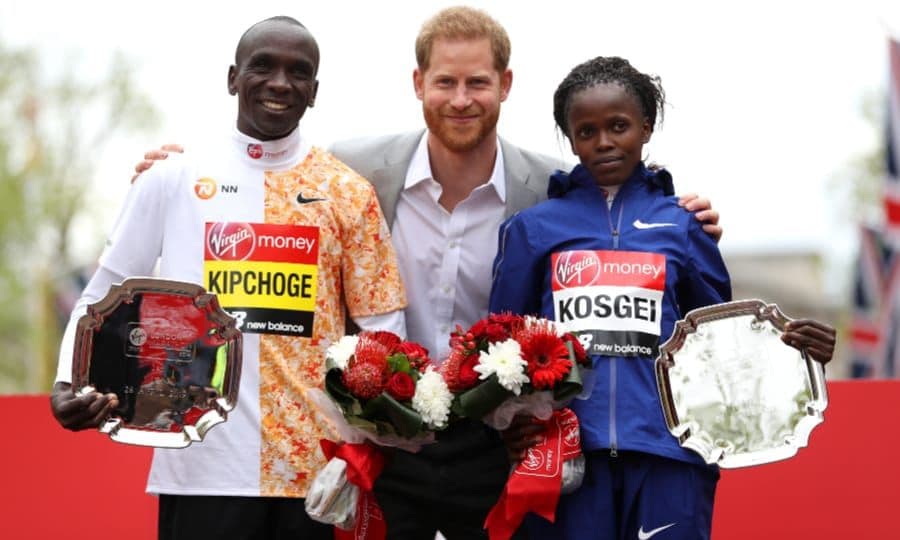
[[490, 57, 834, 540]]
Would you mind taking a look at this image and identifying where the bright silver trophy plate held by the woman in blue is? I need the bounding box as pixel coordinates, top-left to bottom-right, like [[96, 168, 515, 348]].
[[656, 300, 828, 468]]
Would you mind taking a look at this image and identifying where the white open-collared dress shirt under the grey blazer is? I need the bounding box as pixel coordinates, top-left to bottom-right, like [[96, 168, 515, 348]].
[[391, 131, 506, 362]]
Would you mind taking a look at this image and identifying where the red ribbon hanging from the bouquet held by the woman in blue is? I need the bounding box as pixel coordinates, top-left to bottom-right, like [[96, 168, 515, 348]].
[[484, 409, 581, 540]]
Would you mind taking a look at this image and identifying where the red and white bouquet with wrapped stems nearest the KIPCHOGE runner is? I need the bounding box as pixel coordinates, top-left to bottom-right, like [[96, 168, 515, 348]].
[[306, 331, 453, 538]]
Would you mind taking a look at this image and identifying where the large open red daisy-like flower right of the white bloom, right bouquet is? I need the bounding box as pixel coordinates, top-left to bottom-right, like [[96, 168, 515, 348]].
[[516, 325, 572, 390]]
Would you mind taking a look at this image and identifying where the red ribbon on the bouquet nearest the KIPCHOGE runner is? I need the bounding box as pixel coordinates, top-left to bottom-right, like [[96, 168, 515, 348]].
[[319, 439, 387, 540]]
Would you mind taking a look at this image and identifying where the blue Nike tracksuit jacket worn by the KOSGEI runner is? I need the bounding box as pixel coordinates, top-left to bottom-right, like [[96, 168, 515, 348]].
[[490, 163, 731, 464]]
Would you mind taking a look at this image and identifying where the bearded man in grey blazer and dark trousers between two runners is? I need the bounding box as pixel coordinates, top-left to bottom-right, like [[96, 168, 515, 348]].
[[331, 8, 567, 540]]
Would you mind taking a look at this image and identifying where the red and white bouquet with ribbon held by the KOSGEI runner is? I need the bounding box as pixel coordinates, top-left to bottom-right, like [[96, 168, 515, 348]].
[[441, 314, 590, 540]]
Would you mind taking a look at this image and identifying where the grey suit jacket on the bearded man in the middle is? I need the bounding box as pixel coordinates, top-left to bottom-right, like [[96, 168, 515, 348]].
[[330, 131, 570, 226]]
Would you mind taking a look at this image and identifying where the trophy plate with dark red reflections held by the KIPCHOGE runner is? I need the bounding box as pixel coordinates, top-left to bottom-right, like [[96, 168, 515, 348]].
[[72, 278, 242, 448]]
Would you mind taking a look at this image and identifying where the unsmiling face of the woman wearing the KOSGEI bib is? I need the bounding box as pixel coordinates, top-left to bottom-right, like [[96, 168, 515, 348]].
[[566, 83, 652, 186]]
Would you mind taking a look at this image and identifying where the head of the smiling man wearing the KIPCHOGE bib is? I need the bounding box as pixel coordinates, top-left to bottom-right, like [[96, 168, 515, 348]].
[[228, 21, 319, 141]]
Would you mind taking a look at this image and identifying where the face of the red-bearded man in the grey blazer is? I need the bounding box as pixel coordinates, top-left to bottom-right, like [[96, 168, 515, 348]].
[[413, 38, 512, 152]]
